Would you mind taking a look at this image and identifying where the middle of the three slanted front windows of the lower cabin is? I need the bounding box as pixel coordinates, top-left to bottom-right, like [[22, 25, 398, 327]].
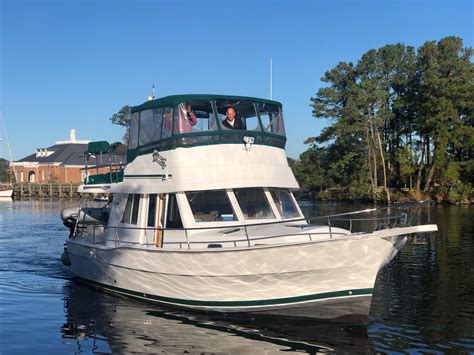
[[234, 188, 275, 219]]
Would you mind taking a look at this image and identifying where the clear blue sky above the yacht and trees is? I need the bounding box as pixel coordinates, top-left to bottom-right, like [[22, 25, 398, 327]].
[[0, 0, 474, 160]]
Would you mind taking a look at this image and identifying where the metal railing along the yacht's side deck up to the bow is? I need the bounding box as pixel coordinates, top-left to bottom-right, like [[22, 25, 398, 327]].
[[76, 201, 433, 249]]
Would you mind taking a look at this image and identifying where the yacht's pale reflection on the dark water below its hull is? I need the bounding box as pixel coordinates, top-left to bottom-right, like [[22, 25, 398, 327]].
[[61, 280, 370, 353]]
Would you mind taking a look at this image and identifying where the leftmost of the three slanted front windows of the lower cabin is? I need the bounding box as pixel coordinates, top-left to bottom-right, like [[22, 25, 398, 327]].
[[186, 190, 237, 222]]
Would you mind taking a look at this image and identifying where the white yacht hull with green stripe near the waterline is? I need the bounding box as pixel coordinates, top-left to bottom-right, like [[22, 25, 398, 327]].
[[68, 228, 426, 319]]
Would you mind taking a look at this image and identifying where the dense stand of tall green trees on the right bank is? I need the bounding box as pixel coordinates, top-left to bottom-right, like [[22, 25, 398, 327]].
[[290, 37, 474, 203]]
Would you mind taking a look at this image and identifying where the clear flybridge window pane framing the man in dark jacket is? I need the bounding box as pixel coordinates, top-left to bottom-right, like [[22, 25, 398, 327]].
[[216, 99, 260, 131]]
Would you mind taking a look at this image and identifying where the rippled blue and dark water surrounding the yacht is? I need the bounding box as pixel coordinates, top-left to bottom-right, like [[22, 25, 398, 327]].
[[0, 201, 474, 354]]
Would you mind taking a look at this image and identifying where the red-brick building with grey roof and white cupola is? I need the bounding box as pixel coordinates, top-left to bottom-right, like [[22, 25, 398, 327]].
[[11, 129, 125, 183]]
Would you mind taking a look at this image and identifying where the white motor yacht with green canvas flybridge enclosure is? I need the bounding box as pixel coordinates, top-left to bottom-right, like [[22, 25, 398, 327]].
[[62, 95, 437, 320]]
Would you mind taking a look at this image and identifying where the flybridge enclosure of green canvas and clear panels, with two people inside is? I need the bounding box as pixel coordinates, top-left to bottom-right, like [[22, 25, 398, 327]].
[[127, 95, 286, 162]]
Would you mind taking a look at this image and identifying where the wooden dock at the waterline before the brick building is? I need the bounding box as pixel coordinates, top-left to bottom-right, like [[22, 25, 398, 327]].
[[13, 183, 80, 198]]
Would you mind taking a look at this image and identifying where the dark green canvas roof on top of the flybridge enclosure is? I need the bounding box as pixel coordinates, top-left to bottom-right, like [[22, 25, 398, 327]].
[[132, 94, 281, 112]]
